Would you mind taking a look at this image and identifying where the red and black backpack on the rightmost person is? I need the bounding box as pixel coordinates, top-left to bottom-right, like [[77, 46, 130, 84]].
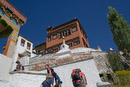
[[71, 69, 81, 82]]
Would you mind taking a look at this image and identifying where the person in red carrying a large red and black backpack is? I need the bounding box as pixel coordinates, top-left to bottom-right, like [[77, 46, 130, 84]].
[[71, 69, 87, 87]]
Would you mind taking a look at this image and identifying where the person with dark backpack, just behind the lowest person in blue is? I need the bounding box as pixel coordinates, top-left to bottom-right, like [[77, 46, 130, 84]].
[[45, 64, 62, 87]]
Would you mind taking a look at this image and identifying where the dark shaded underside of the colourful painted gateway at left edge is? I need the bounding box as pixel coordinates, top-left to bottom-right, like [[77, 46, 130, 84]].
[[0, 16, 13, 39]]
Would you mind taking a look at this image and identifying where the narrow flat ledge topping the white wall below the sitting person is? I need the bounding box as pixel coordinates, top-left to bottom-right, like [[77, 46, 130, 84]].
[[9, 71, 47, 75]]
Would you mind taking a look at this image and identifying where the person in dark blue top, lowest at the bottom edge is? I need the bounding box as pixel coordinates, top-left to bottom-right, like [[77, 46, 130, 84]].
[[40, 77, 54, 87]]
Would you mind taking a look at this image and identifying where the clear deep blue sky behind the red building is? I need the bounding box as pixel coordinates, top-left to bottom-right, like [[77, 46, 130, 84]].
[[0, 0, 130, 52]]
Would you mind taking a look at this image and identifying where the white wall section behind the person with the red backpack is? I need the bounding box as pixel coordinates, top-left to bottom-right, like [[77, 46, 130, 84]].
[[42, 59, 101, 87]]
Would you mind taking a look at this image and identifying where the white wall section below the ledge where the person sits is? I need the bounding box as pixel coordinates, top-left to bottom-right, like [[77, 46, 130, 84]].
[[8, 73, 46, 87]]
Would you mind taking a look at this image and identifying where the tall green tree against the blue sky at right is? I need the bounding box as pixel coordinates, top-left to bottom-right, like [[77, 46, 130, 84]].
[[107, 7, 130, 53]]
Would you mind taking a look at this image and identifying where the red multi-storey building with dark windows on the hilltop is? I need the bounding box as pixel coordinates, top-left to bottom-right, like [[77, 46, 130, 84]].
[[46, 19, 89, 52]]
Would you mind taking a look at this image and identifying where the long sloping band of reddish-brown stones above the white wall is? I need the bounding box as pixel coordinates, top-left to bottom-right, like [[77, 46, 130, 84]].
[[24, 53, 92, 70]]
